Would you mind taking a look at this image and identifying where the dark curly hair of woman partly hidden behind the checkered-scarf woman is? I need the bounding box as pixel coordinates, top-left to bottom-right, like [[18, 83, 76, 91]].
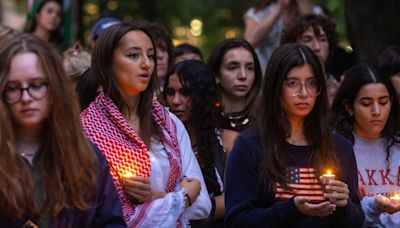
[[163, 60, 222, 191]]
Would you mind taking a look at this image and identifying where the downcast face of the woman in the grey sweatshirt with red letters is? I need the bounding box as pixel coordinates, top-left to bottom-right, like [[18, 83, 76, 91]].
[[348, 83, 392, 139]]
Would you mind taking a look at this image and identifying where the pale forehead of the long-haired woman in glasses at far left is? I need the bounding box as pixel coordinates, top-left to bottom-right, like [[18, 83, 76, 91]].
[[8, 52, 45, 81]]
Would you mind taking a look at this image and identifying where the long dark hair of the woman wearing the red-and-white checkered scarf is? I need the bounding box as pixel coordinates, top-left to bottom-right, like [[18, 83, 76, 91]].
[[91, 23, 161, 147]]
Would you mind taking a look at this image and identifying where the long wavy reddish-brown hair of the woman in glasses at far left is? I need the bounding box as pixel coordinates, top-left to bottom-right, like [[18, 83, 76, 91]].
[[0, 34, 98, 217]]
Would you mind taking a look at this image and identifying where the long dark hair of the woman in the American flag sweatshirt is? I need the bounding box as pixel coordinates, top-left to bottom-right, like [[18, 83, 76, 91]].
[[256, 44, 337, 189]]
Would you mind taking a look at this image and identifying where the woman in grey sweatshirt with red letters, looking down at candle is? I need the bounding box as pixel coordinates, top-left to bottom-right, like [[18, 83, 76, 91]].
[[331, 64, 400, 227]]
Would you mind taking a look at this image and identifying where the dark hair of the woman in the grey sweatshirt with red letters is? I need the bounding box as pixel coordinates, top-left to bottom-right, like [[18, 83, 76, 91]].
[[330, 63, 400, 162]]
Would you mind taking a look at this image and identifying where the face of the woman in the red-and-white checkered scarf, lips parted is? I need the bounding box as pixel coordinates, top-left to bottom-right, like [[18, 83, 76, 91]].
[[112, 31, 155, 96]]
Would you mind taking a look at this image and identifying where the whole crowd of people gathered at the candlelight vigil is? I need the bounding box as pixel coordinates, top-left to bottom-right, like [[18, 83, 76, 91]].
[[0, 0, 400, 227]]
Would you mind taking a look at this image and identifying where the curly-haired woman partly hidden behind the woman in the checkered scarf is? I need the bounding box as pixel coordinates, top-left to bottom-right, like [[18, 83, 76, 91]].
[[163, 60, 226, 227]]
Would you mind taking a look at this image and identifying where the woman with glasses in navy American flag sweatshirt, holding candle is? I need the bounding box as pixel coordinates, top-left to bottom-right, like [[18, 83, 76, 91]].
[[225, 44, 364, 227]]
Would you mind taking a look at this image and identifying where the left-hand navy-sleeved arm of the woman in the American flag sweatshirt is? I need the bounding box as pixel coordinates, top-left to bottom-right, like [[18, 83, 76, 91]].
[[225, 136, 303, 227]]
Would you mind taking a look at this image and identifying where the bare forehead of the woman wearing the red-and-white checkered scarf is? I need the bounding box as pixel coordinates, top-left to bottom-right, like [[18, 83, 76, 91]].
[[118, 31, 153, 50]]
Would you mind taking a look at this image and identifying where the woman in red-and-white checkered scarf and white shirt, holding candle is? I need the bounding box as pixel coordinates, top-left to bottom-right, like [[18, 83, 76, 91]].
[[81, 23, 211, 227]]
